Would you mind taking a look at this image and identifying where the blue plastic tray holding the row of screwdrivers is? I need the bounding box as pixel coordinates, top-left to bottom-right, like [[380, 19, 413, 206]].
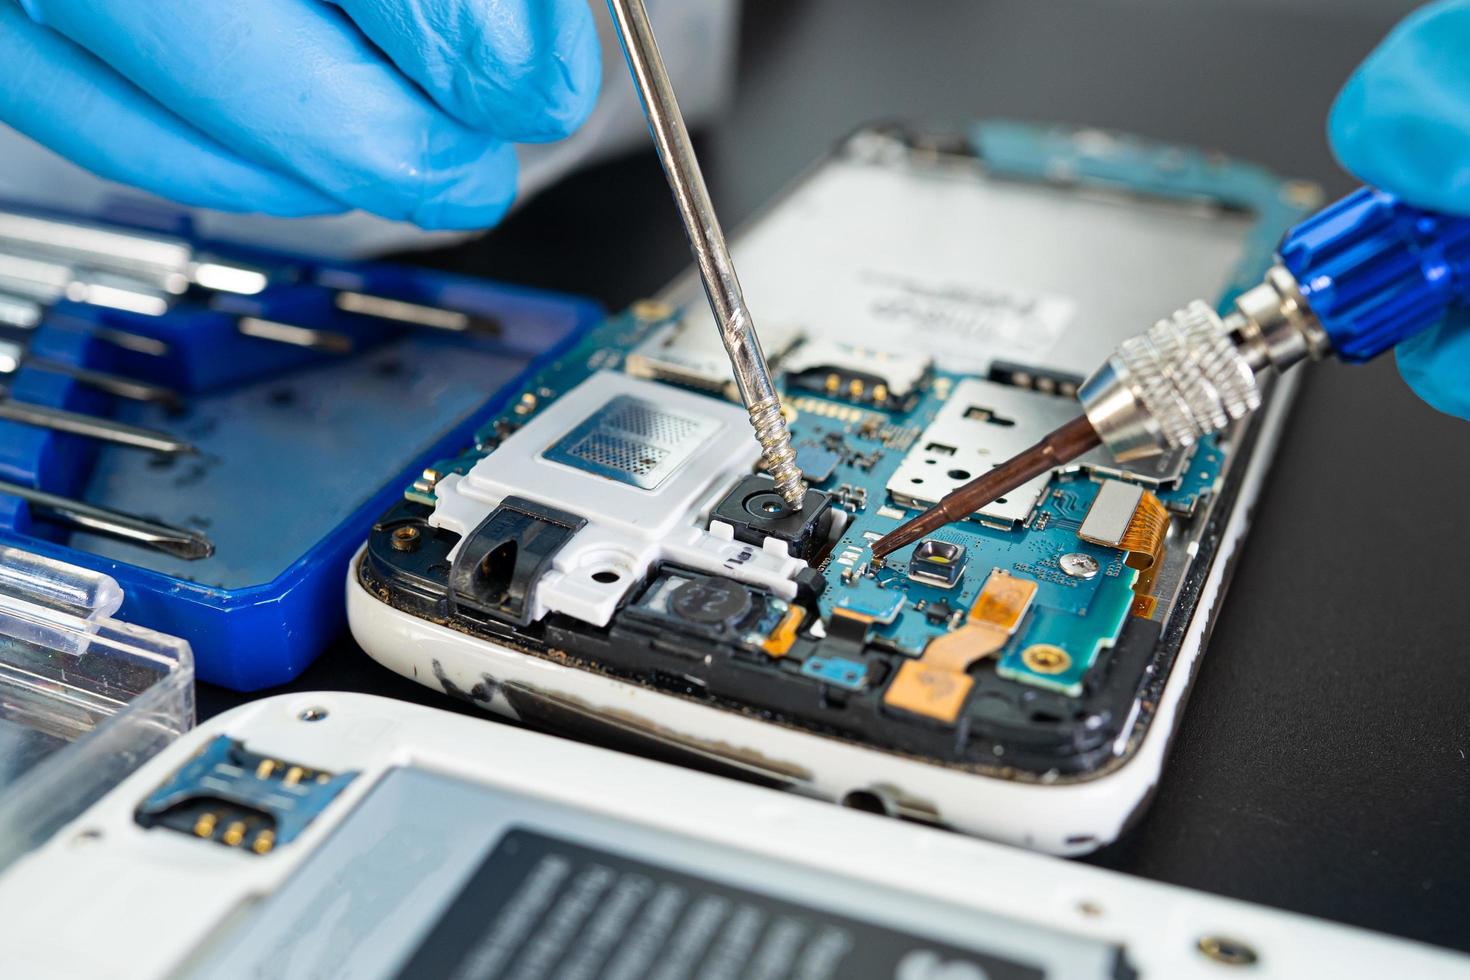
[[0, 202, 603, 691]]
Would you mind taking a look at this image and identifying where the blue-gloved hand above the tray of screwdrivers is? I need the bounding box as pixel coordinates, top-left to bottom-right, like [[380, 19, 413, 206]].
[[0, 0, 601, 228]]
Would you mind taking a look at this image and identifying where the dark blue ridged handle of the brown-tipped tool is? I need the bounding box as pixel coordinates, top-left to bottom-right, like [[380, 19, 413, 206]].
[[1279, 188, 1470, 361]]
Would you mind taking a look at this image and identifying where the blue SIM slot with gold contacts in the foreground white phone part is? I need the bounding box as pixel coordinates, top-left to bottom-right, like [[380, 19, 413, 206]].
[[135, 735, 357, 854]]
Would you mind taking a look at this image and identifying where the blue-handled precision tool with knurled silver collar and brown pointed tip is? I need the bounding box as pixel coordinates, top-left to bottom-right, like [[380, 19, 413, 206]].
[[873, 188, 1470, 558]]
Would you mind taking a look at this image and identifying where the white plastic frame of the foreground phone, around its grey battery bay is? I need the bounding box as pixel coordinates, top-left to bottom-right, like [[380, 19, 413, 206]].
[[0, 693, 1470, 980]]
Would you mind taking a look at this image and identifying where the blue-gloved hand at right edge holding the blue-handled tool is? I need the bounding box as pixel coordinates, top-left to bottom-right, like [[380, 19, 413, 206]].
[[1327, 0, 1470, 419]]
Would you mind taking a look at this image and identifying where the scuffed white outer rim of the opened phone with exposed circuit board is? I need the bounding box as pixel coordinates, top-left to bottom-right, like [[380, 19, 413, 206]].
[[347, 375, 1297, 855]]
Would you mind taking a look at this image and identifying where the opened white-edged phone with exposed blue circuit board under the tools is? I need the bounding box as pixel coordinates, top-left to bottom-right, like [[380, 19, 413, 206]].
[[348, 123, 1316, 852]]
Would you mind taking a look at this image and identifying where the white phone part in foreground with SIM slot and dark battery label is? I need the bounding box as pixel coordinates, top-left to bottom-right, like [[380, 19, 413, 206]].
[[0, 693, 1466, 980]]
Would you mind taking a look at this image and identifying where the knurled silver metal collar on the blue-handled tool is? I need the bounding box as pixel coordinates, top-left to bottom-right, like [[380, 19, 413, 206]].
[[1078, 301, 1261, 463]]
